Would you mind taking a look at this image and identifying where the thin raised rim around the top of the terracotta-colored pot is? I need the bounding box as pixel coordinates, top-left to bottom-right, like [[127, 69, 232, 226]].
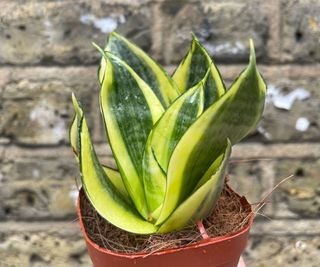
[[77, 185, 254, 259]]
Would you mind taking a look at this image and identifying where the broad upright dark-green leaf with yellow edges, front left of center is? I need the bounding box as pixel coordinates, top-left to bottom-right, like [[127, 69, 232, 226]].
[[100, 46, 164, 219]]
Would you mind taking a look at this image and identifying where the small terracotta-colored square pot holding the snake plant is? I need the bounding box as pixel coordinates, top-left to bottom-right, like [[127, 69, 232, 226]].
[[78, 189, 254, 267]]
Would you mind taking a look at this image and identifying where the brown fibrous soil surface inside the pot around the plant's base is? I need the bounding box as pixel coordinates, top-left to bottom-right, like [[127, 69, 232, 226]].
[[80, 182, 251, 253]]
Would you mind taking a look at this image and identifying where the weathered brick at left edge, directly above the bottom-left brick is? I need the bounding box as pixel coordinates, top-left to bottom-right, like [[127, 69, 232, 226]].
[[0, 146, 114, 220]]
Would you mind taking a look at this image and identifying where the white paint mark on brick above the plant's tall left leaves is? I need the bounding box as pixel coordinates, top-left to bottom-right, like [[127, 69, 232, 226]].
[[80, 14, 120, 33]]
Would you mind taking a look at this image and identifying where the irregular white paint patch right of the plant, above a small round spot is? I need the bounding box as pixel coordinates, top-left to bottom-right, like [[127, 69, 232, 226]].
[[266, 84, 311, 110]]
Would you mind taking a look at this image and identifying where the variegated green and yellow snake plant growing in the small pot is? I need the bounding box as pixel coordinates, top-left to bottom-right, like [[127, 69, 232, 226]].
[[70, 33, 266, 234]]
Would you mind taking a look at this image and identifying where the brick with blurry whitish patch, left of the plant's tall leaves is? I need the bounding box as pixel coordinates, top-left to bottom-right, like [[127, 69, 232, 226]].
[[0, 68, 101, 145]]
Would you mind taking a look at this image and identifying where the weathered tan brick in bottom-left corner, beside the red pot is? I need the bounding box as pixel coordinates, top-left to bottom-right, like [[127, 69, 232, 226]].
[[0, 222, 92, 267]]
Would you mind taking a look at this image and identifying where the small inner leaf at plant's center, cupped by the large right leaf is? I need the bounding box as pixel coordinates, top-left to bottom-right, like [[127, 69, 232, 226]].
[[151, 78, 205, 174]]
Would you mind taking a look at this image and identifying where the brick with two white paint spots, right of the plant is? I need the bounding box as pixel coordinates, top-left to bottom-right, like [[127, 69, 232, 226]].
[[260, 74, 320, 141]]
